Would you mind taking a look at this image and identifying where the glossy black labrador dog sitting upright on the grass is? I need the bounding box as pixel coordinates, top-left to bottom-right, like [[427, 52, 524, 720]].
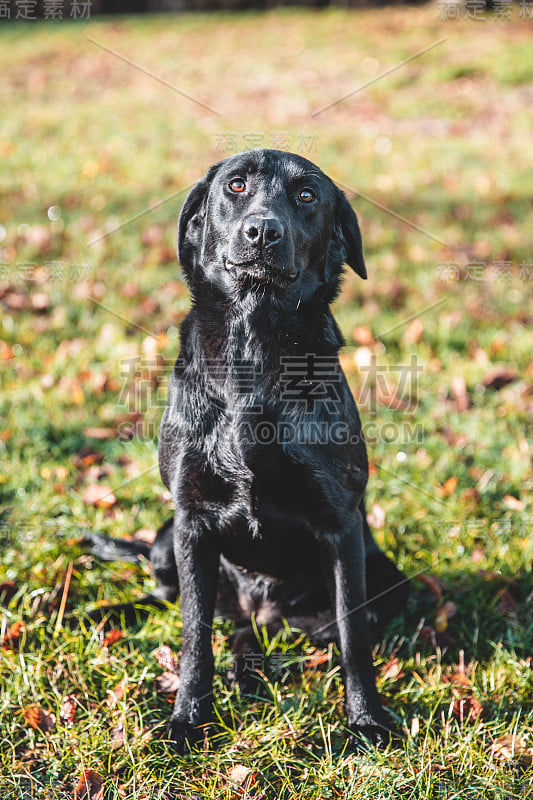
[[85, 149, 408, 752]]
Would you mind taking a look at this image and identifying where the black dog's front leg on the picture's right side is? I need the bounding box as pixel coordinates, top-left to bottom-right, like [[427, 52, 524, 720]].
[[324, 511, 389, 748]]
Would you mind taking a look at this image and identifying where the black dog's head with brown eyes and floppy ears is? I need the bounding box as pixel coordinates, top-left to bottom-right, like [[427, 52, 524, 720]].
[[178, 149, 366, 298]]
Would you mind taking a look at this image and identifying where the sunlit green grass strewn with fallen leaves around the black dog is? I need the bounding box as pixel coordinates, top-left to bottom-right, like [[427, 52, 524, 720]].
[[0, 6, 533, 800]]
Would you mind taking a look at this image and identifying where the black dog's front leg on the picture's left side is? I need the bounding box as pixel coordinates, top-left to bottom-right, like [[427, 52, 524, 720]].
[[168, 512, 219, 754]]
